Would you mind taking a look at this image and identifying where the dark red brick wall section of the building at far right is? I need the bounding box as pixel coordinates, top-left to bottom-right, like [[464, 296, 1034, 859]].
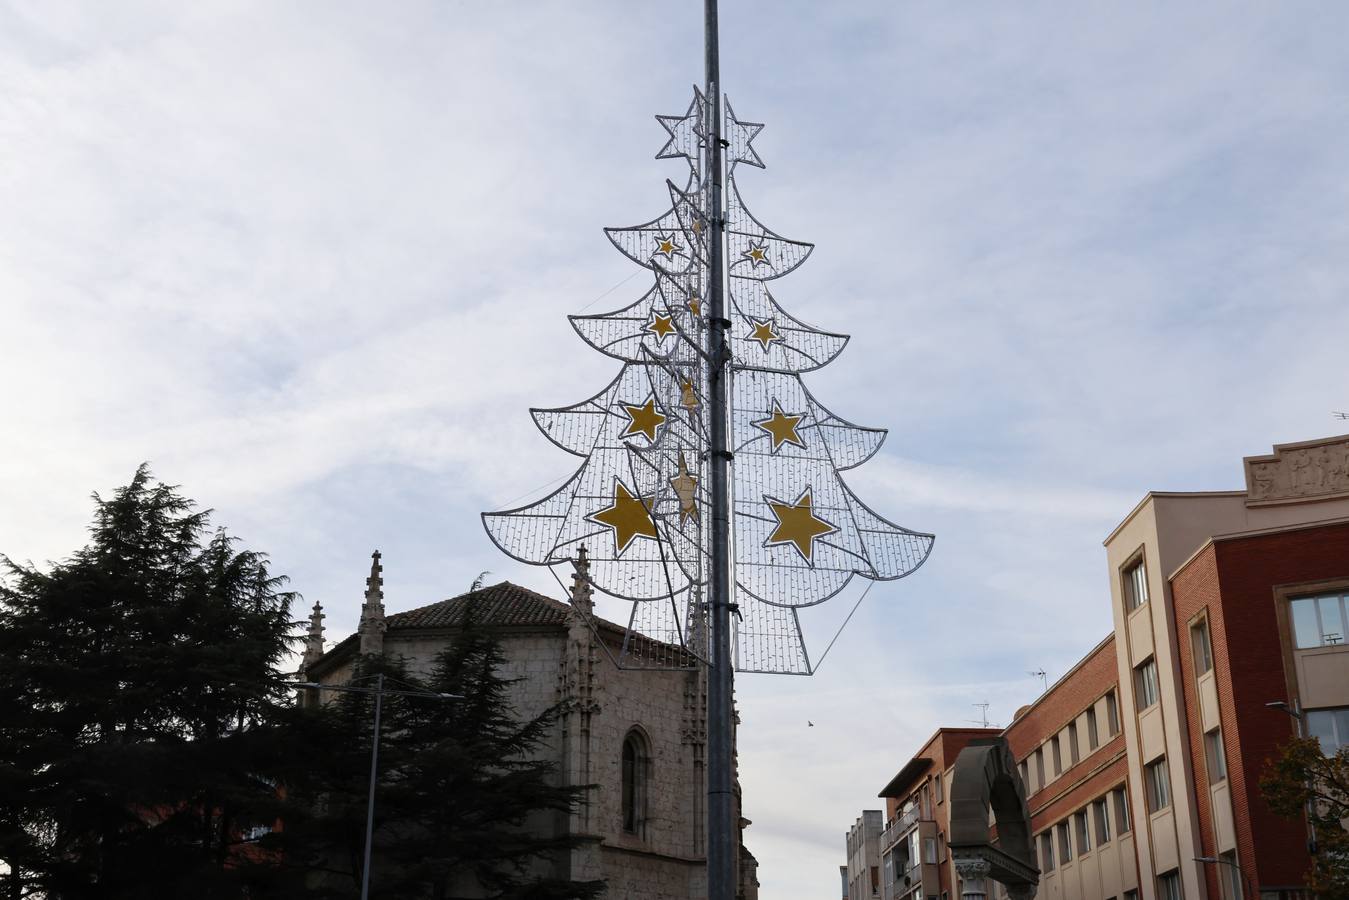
[[1172, 525, 1349, 885]]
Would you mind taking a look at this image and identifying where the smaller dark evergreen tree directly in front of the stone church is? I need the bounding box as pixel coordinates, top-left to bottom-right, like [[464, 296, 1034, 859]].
[[297, 604, 603, 900]]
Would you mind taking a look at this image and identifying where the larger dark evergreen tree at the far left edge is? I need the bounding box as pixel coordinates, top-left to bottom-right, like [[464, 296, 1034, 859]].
[[0, 466, 306, 900]]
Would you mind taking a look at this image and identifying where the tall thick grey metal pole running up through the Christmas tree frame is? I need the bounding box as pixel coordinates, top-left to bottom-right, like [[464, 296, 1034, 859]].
[[704, 0, 738, 900]]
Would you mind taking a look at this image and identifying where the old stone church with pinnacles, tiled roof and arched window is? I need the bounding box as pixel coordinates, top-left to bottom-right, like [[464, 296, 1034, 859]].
[[302, 549, 758, 900]]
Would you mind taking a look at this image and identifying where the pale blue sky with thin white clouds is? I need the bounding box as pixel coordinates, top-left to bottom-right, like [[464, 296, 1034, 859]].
[[0, 0, 1349, 900]]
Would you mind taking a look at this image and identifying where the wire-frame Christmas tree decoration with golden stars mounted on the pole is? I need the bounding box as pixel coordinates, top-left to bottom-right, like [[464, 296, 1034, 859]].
[[483, 88, 932, 673]]
